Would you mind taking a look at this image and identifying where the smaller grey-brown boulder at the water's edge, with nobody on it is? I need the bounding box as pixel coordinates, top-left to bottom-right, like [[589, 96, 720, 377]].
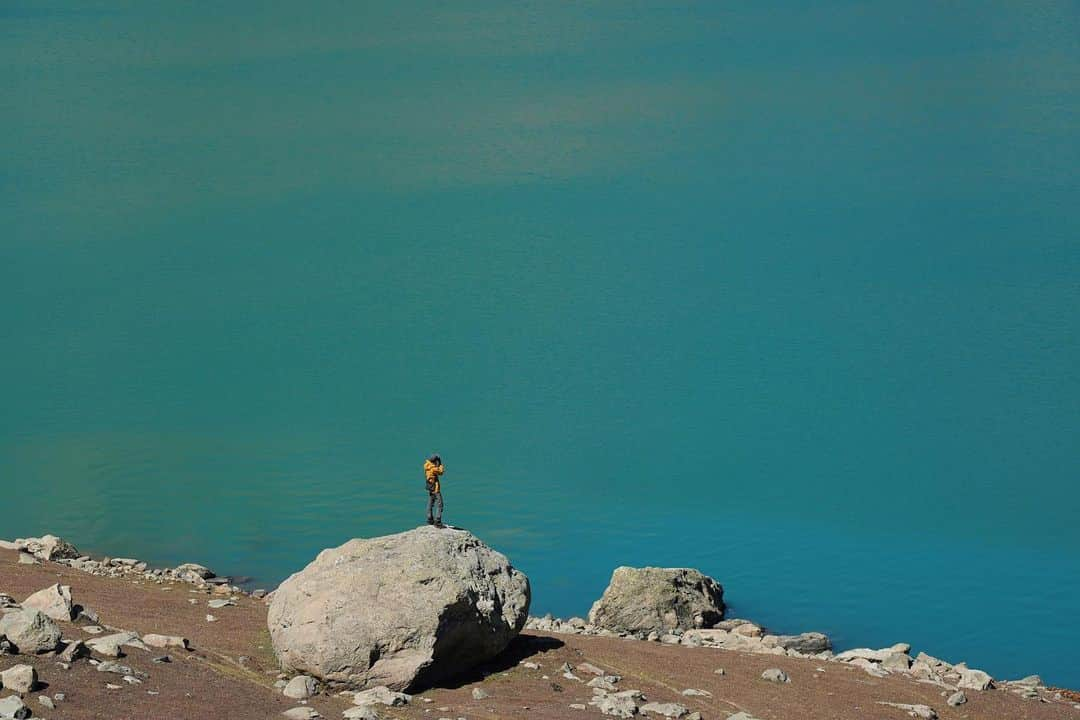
[[589, 568, 724, 633]]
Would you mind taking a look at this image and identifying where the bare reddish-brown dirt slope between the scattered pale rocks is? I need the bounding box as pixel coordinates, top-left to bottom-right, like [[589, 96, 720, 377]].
[[0, 551, 1080, 720]]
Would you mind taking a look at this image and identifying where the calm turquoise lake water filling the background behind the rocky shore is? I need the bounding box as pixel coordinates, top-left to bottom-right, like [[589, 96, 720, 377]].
[[0, 0, 1080, 688]]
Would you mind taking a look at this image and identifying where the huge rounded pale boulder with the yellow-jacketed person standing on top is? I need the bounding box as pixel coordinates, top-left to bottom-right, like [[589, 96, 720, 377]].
[[267, 527, 530, 690]]
